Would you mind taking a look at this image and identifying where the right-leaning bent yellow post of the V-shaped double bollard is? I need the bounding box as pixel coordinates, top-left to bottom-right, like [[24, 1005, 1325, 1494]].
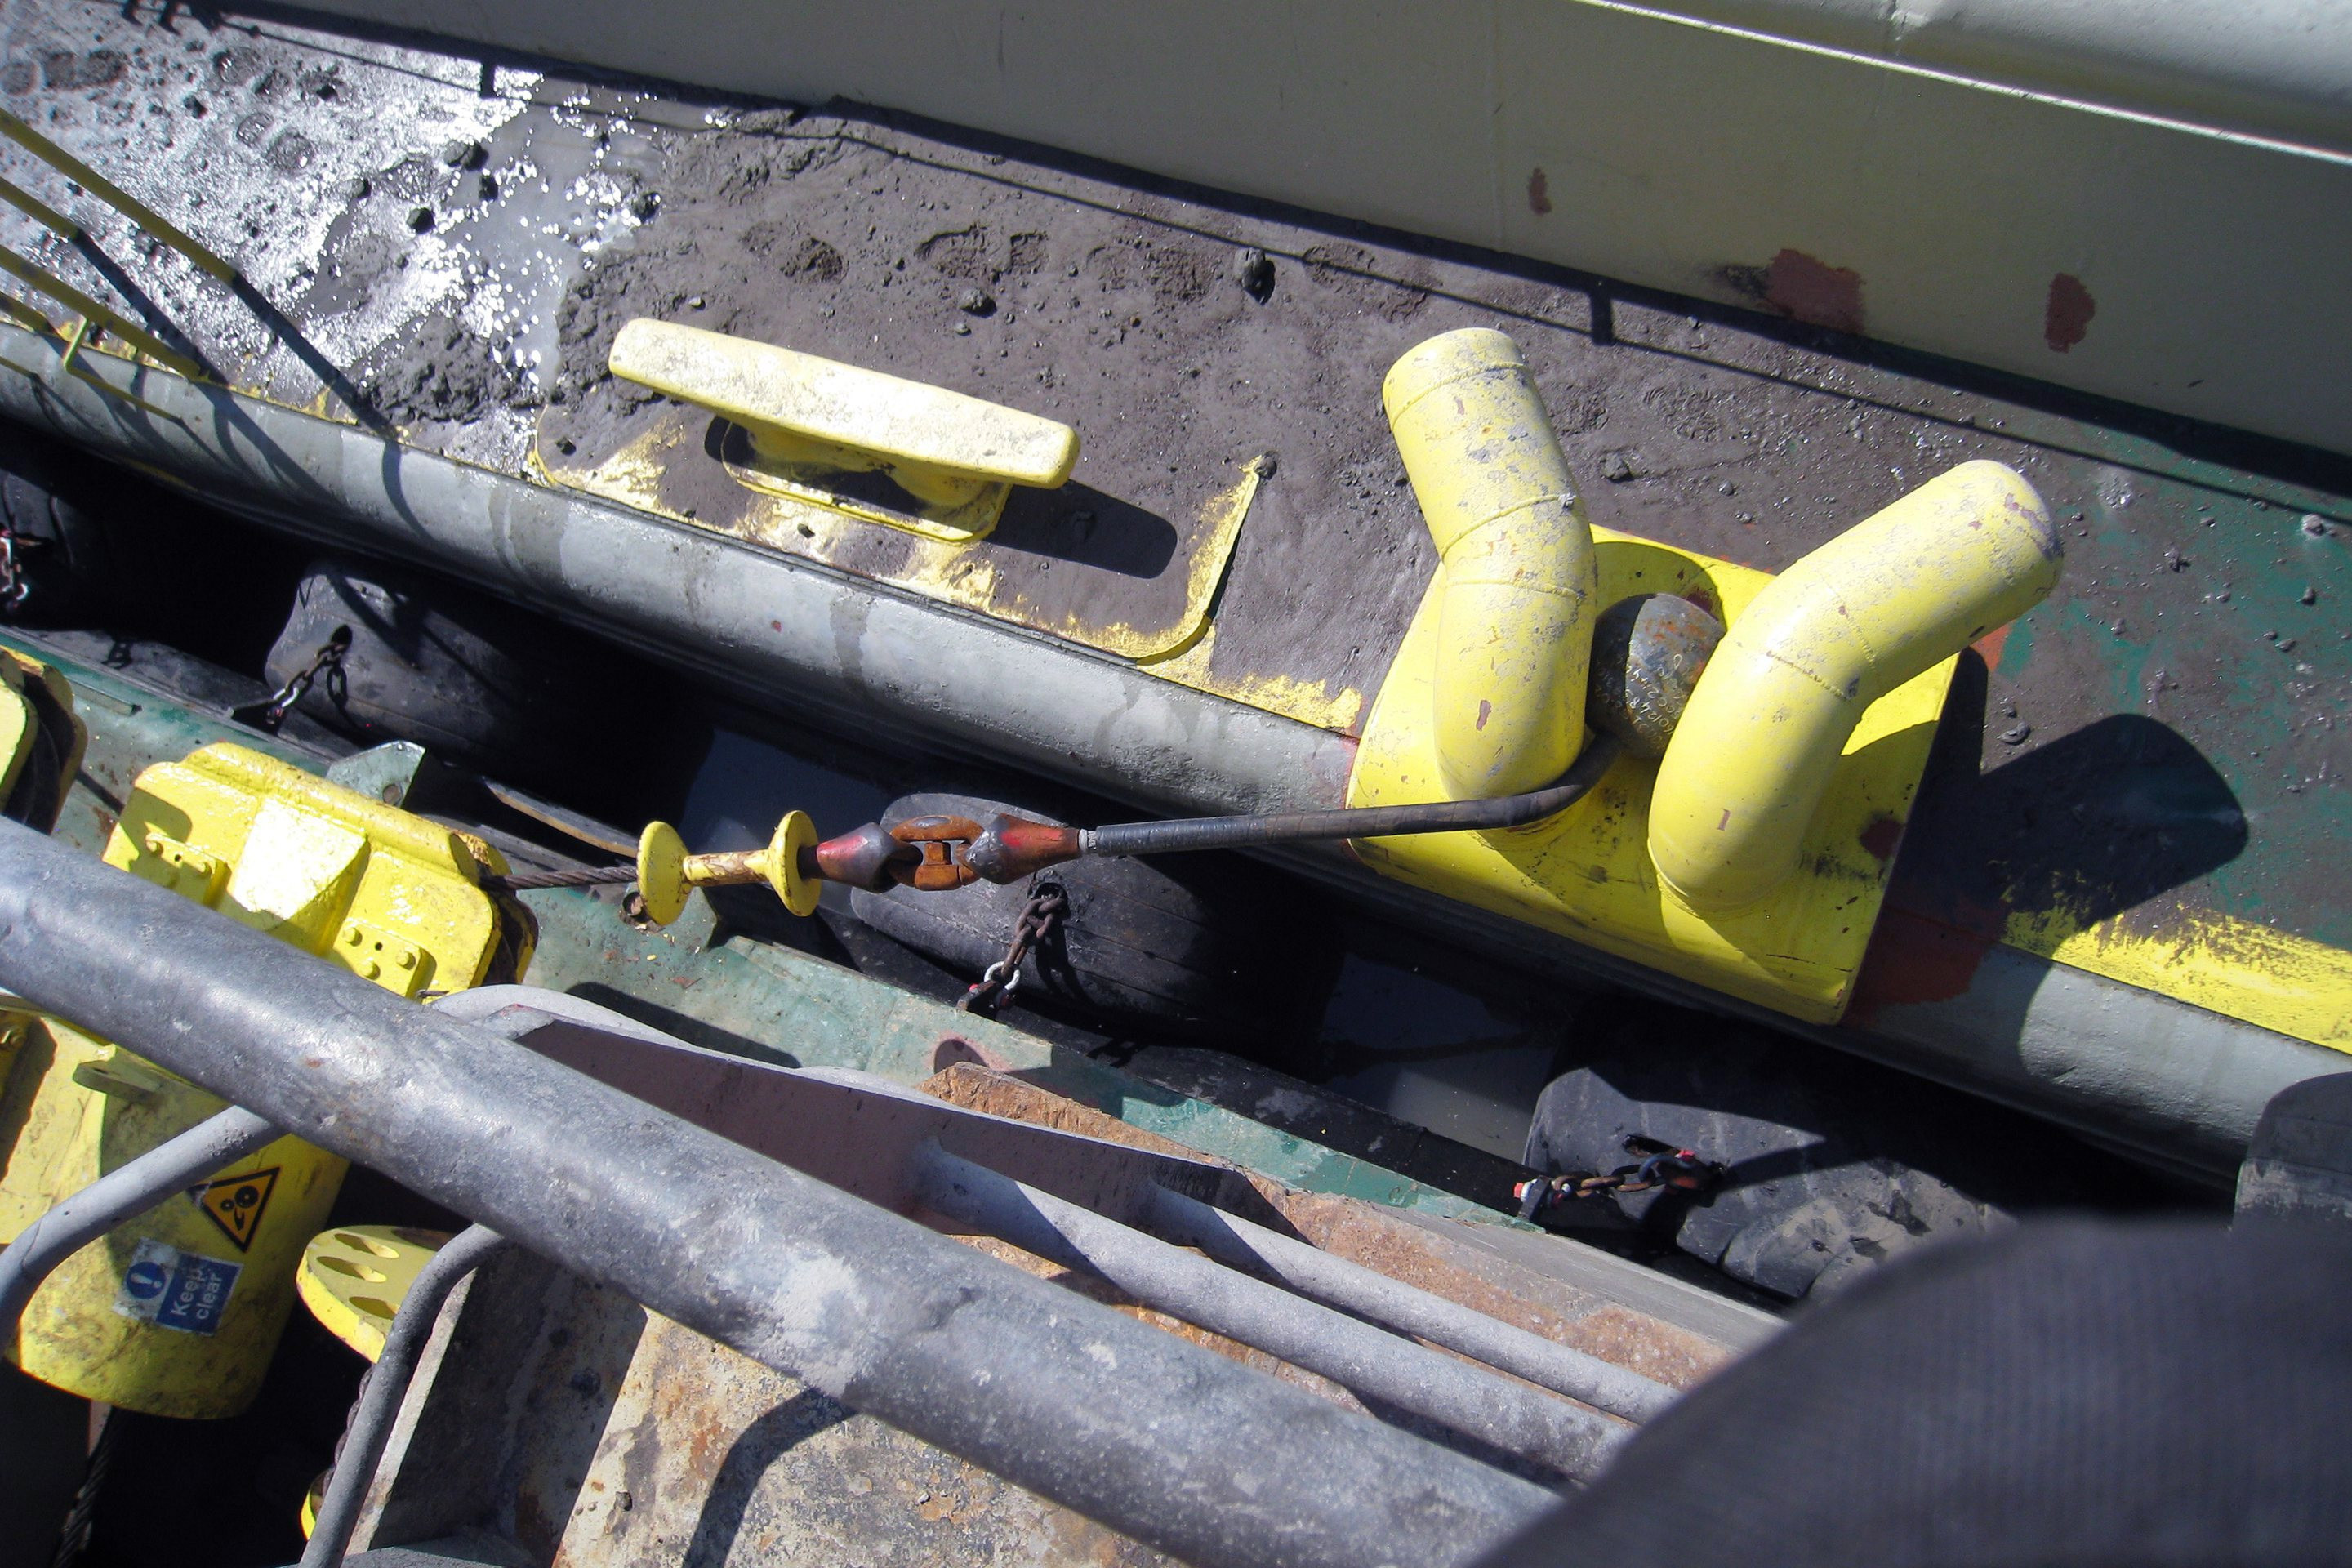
[[1649, 463, 2060, 910]]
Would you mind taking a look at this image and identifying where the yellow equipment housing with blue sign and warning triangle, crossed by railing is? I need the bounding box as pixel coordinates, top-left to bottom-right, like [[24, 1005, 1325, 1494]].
[[0, 746, 529, 1418]]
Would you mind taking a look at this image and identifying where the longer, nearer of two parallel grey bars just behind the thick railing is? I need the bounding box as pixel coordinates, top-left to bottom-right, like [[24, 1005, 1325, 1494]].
[[915, 1143, 1633, 1481]]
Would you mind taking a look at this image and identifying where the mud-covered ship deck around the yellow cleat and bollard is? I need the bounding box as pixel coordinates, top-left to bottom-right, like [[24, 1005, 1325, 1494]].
[[0, 0, 2352, 982]]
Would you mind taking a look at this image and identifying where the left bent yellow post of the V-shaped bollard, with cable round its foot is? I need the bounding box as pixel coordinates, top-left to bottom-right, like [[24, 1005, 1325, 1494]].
[[1381, 327, 1599, 800]]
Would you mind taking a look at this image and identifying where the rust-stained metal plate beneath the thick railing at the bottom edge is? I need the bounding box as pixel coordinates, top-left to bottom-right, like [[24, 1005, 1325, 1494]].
[[358, 1249, 1169, 1568]]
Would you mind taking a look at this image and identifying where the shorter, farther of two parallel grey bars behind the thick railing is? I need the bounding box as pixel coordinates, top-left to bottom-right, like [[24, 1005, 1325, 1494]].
[[1152, 1187, 1679, 1423]]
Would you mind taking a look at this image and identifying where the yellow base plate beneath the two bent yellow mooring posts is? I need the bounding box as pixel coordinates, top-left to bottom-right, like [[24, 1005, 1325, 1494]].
[[1348, 529, 1957, 1022]]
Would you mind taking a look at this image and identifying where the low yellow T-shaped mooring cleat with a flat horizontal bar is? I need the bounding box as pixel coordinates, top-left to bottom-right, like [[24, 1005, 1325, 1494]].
[[607, 318, 1077, 541]]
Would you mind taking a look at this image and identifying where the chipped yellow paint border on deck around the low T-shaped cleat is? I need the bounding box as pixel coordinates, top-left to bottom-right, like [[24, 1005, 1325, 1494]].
[[532, 409, 1263, 663]]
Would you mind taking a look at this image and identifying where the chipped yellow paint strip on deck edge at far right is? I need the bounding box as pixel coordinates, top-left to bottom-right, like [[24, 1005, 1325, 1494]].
[[2002, 905, 2352, 1051]]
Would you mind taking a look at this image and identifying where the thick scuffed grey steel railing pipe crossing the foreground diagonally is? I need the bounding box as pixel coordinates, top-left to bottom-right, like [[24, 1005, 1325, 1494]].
[[0, 821, 1552, 1568]]
